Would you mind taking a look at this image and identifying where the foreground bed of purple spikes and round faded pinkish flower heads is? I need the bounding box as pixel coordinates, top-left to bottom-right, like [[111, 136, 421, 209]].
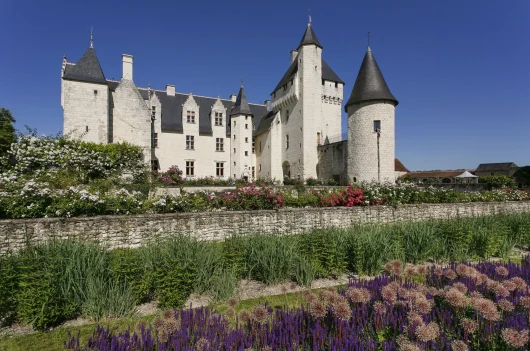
[[65, 256, 530, 351]]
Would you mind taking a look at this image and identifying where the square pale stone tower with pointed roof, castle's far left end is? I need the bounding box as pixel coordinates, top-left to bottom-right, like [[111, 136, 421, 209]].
[[61, 34, 111, 143]]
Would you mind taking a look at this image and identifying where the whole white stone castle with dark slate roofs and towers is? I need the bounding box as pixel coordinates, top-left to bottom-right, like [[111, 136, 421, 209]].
[[61, 22, 398, 183]]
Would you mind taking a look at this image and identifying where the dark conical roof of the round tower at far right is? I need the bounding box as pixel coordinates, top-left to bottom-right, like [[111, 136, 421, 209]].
[[344, 47, 398, 112]]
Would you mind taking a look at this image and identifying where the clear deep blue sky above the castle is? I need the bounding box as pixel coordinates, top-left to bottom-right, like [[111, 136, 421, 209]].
[[0, 0, 530, 170]]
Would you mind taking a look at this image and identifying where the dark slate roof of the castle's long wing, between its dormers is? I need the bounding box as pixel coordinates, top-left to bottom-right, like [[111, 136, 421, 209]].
[[108, 80, 267, 134]]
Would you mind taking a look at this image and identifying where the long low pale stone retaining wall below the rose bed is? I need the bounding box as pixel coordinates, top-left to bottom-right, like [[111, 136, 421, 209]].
[[0, 202, 530, 253]]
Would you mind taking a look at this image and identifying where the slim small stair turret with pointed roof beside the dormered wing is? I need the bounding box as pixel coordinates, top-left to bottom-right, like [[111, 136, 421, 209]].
[[230, 84, 253, 180]]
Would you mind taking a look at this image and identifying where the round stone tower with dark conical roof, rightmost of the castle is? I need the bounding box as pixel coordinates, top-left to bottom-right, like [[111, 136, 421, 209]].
[[345, 47, 398, 182]]
